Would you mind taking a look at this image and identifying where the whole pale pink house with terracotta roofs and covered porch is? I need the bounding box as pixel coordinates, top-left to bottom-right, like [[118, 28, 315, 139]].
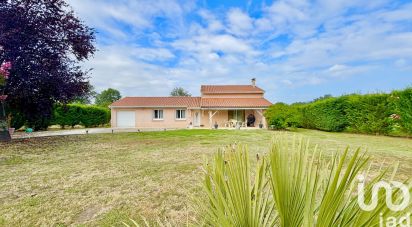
[[110, 79, 272, 128]]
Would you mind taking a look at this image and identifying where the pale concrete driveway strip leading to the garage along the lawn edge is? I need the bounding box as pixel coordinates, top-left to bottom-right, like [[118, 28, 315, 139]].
[[12, 128, 176, 139]]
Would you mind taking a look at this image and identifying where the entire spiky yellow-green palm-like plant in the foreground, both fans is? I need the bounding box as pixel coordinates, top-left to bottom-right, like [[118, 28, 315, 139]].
[[200, 137, 411, 227]]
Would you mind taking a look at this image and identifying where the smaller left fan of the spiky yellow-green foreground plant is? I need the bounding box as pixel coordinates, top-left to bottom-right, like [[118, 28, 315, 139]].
[[200, 146, 276, 227]]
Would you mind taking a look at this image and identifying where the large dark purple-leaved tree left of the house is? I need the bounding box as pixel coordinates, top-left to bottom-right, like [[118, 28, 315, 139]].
[[0, 0, 95, 129]]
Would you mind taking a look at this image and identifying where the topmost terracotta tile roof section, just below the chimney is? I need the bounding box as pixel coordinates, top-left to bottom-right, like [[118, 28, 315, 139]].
[[200, 85, 264, 94]]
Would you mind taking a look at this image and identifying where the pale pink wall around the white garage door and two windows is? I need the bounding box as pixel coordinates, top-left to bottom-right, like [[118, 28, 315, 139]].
[[111, 108, 192, 128]]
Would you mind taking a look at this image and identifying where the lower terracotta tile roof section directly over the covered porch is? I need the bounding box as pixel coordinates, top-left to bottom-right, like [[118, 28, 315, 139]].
[[201, 98, 272, 108]]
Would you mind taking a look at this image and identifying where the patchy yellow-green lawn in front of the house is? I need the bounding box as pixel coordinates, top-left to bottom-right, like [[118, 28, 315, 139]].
[[0, 130, 412, 226]]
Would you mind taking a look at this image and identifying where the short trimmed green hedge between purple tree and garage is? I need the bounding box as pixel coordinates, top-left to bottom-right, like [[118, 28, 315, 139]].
[[51, 104, 110, 128]]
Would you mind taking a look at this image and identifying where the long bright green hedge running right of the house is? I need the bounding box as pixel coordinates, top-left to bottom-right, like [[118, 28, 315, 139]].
[[266, 88, 412, 135]]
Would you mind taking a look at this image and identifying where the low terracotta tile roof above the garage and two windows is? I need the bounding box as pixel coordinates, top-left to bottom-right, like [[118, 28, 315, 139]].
[[110, 97, 200, 107]]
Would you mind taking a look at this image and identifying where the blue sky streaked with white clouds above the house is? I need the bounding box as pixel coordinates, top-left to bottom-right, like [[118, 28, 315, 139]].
[[68, 0, 412, 103]]
